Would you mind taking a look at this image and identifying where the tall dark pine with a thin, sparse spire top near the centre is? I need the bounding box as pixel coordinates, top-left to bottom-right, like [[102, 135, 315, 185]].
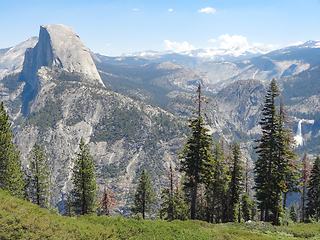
[[178, 84, 212, 219]]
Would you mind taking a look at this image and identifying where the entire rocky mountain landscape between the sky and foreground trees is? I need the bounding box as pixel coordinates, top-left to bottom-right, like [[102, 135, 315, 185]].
[[0, 24, 320, 212]]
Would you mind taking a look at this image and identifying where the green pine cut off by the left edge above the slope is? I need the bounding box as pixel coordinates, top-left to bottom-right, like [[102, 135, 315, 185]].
[[0, 102, 25, 198]]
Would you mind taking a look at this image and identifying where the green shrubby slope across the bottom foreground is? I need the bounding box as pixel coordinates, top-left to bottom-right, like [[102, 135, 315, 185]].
[[0, 190, 320, 240]]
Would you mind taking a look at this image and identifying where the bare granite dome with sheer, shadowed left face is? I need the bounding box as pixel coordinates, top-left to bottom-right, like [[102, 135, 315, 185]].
[[22, 24, 104, 89]]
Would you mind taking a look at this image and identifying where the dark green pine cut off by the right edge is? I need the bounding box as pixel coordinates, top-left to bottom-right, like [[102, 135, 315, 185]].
[[307, 156, 320, 222]]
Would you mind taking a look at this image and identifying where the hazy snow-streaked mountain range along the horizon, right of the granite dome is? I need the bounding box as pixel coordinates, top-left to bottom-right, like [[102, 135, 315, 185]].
[[97, 40, 320, 88]]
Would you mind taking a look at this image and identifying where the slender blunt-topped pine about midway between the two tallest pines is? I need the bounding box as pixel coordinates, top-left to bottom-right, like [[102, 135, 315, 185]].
[[229, 143, 244, 222]]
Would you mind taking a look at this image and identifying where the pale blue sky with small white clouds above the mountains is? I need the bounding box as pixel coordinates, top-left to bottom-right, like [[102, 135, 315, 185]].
[[0, 0, 320, 56]]
